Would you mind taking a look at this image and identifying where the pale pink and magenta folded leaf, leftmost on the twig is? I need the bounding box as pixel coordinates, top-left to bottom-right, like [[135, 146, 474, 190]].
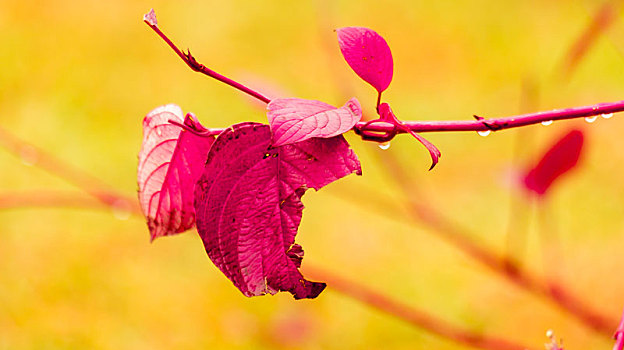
[[138, 104, 214, 240]]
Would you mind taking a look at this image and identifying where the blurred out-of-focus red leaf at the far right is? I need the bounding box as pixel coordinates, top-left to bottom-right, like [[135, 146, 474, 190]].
[[524, 130, 583, 196]]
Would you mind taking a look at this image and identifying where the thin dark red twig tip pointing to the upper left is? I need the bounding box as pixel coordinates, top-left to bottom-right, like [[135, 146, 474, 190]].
[[143, 10, 271, 103]]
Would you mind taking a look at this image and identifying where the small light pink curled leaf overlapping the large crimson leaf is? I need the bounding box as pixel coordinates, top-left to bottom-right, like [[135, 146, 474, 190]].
[[267, 98, 362, 146]]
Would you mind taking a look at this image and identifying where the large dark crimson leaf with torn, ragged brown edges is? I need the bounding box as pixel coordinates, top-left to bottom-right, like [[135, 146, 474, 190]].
[[195, 123, 361, 299]]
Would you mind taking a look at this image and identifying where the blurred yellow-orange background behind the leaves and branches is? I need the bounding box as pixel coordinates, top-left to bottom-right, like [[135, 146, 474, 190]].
[[0, 0, 624, 349]]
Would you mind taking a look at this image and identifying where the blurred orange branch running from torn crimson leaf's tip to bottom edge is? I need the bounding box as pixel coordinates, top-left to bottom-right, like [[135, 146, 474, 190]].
[[306, 266, 528, 350]]
